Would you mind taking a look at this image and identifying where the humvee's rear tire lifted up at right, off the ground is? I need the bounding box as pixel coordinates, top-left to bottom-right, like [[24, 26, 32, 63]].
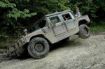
[[79, 24, 90, 39]]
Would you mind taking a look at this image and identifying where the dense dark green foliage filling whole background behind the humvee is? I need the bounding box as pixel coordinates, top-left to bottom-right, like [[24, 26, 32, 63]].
[[0, 0, 105, 34]]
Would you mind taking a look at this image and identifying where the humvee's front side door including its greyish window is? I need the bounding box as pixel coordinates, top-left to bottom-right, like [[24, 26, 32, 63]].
[[49, 15, 67, 36]]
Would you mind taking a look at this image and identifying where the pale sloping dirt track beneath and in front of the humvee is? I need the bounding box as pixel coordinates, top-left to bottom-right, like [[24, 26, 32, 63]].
[[0, 35, 105, 69]]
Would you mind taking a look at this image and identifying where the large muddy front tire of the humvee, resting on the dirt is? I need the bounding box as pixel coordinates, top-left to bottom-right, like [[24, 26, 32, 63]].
[[27, 37, 49, 59]]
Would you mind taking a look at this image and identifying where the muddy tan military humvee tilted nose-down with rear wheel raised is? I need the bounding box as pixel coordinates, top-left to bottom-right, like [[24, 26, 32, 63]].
[[9, 10, 90, 58]]
